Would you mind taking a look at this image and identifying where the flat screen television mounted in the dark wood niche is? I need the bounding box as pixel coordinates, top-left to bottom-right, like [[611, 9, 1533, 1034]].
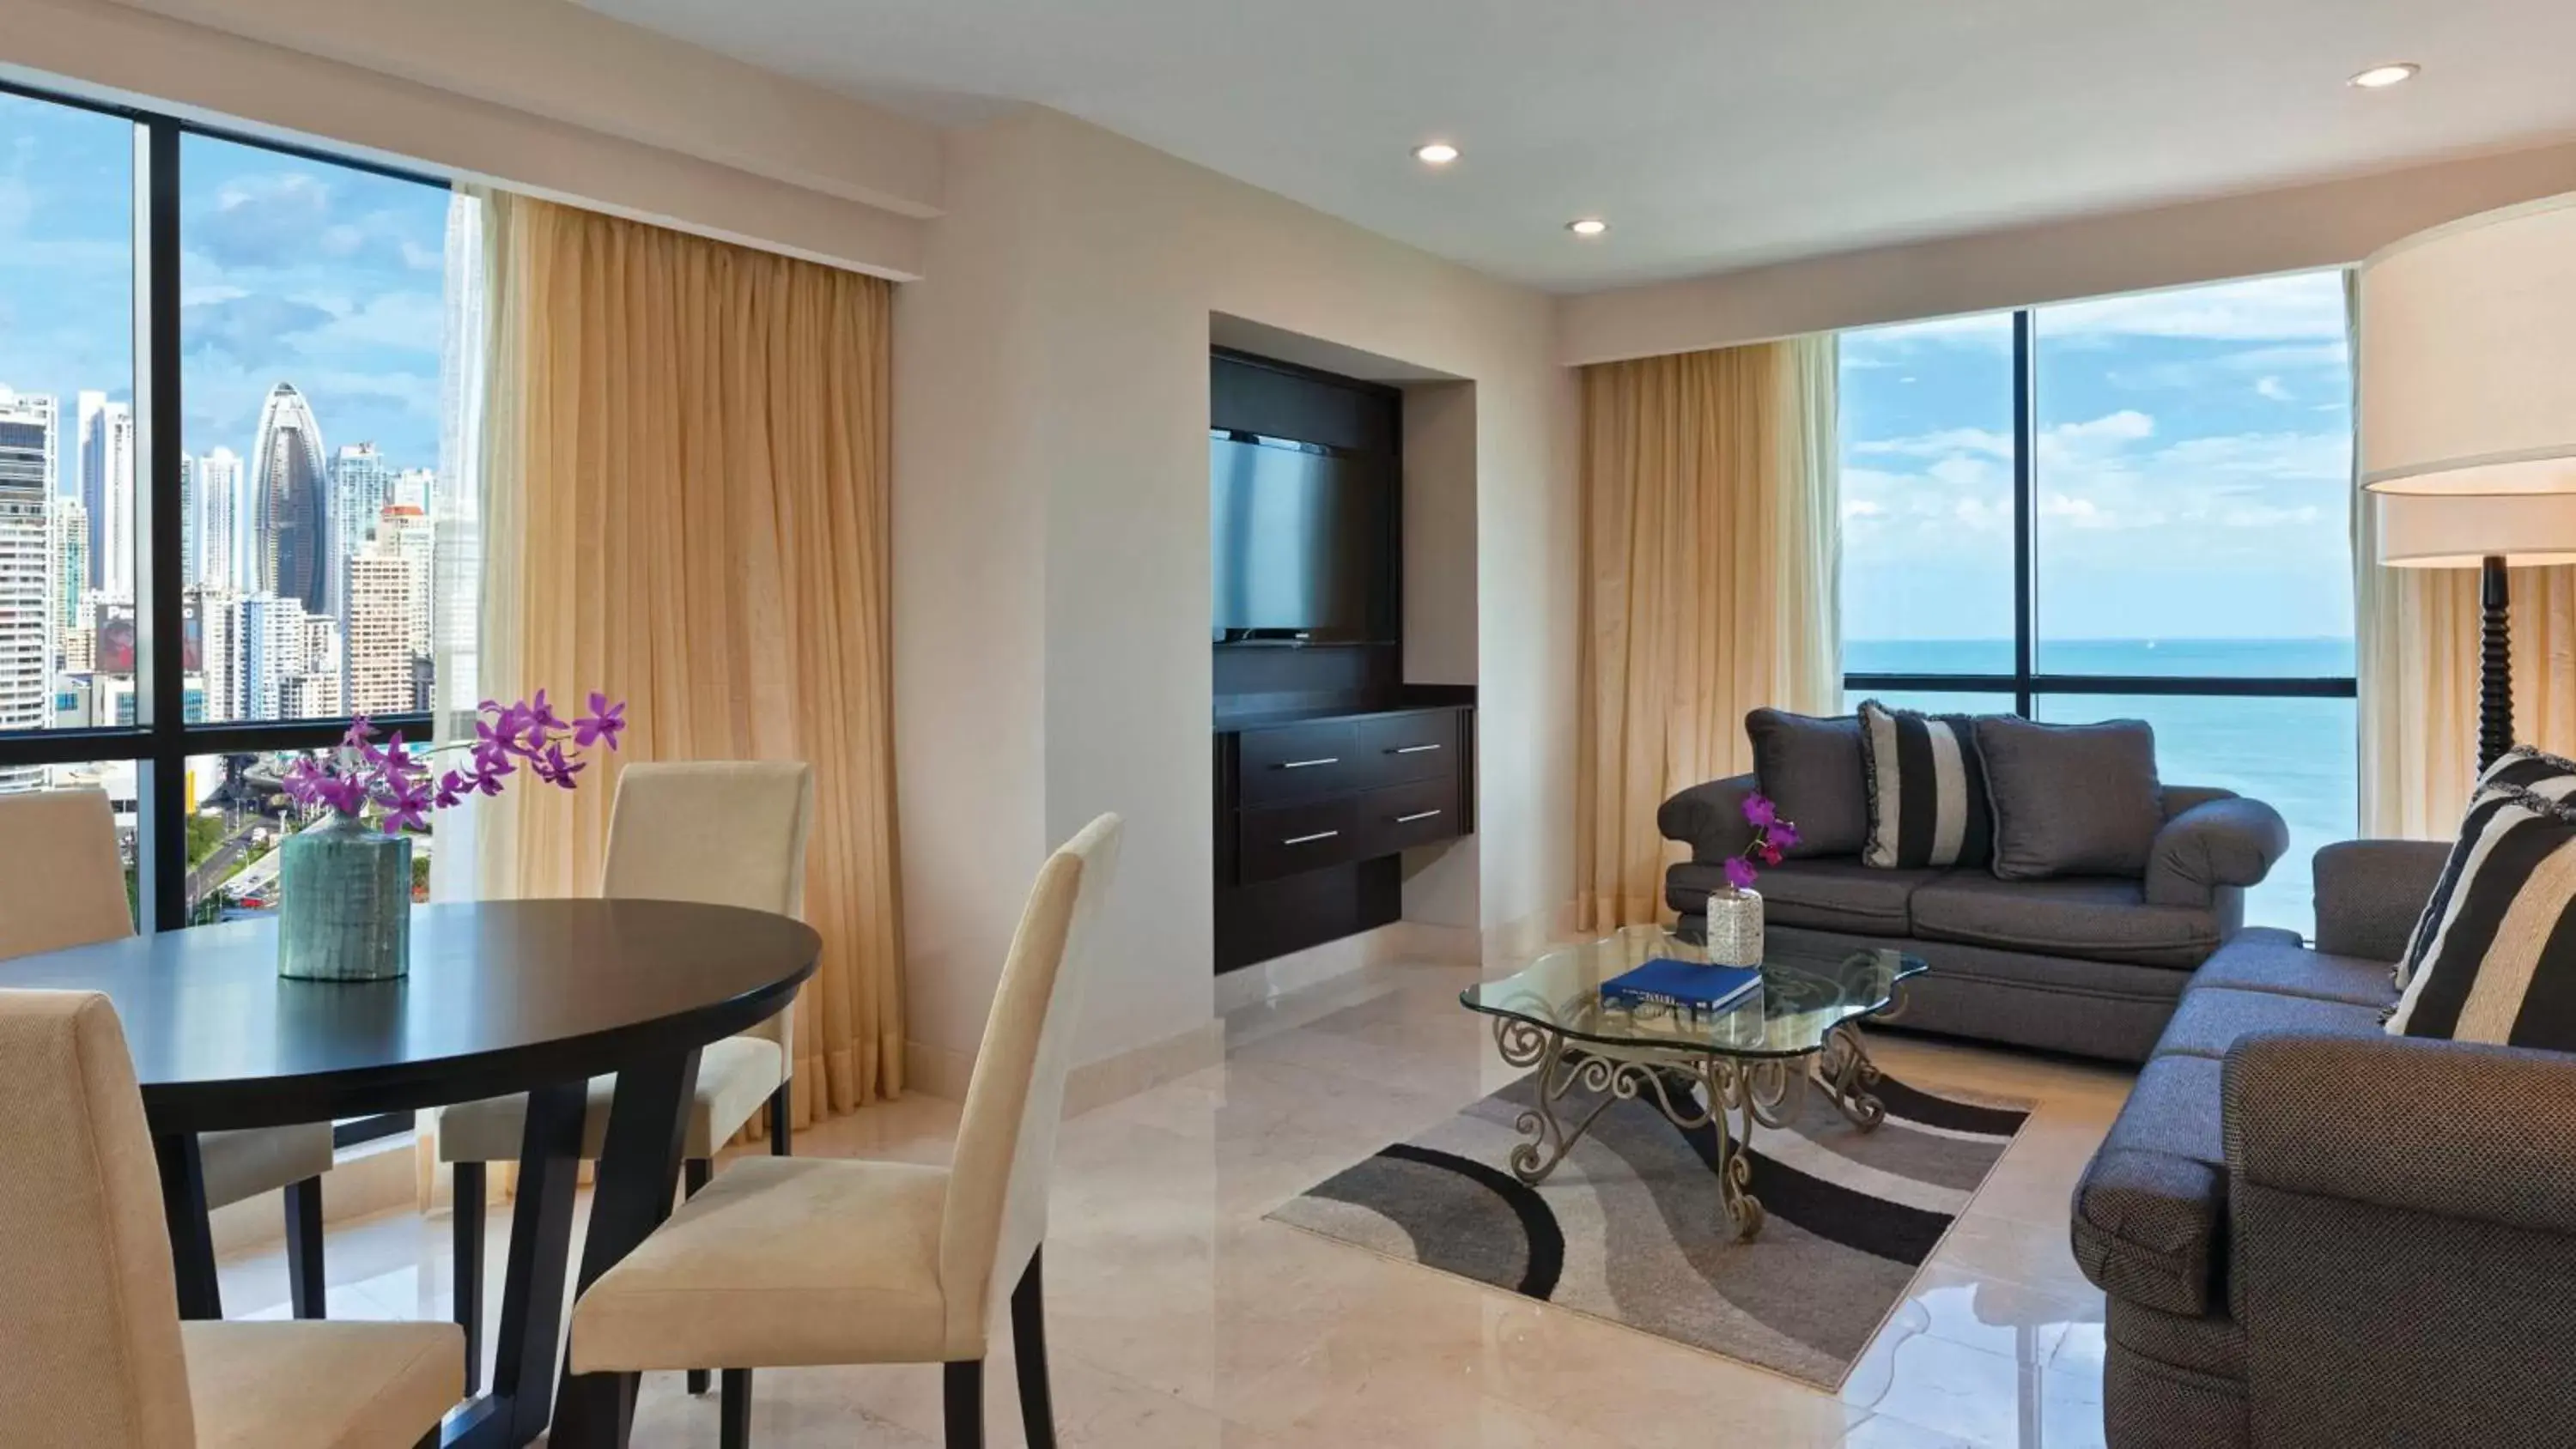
[[1208, 430, 1396, 644]]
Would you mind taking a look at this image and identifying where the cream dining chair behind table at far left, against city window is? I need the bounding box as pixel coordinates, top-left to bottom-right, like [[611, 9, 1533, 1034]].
[[0, 790, 330, 1318]]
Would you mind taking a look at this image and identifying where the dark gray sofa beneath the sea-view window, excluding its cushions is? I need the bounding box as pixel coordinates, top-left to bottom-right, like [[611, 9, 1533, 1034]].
[[1656, 774, 2290, 1063]]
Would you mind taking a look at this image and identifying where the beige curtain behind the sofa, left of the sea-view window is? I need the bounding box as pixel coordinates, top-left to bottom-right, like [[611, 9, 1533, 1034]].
[[1574, 337, 1842, 929]]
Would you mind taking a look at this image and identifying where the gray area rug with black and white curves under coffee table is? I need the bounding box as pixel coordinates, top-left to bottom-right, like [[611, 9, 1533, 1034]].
[[1270, 1060, 2030, 1390]]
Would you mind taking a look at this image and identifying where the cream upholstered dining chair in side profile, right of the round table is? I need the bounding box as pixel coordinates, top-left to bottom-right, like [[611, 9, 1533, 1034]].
[[556, 815, 1118, 1449]]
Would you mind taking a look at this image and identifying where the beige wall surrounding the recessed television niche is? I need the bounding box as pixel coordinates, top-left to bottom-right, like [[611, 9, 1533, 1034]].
[[896, 113, 1577, 1060]]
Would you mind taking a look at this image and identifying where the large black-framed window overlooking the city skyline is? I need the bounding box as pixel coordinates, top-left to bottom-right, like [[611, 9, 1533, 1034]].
[[0, 79, 474, 929]]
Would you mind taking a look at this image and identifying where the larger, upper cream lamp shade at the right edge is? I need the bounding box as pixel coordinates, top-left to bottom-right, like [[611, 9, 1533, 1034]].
[[2357, 196, 2576, 494]]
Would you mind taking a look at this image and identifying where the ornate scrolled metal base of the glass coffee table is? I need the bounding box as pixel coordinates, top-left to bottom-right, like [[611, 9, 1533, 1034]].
[[1494, 1016, 1888, 1240]]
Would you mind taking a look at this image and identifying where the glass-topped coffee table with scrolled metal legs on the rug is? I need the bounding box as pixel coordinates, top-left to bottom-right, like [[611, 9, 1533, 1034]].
[[1458, 926, 1924, 1238]]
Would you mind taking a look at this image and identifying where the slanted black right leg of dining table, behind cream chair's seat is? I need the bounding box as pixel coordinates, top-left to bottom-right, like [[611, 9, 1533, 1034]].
[[546, 1050, 698, 1449]]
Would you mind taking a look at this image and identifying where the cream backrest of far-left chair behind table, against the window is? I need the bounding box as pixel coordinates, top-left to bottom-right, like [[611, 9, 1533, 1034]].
[[0, 790, 134, 960]]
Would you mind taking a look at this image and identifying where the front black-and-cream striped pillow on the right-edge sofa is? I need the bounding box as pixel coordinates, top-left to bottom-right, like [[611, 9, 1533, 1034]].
[[2388, 785, 2576, 1050]]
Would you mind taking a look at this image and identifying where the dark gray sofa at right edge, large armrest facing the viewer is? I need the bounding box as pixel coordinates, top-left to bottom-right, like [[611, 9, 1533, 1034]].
[[2074, 841, 2576, 1449]]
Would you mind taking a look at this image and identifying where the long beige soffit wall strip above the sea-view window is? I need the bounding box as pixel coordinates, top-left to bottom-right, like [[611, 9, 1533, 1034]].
[[1558, 144, 2576, 363]]
